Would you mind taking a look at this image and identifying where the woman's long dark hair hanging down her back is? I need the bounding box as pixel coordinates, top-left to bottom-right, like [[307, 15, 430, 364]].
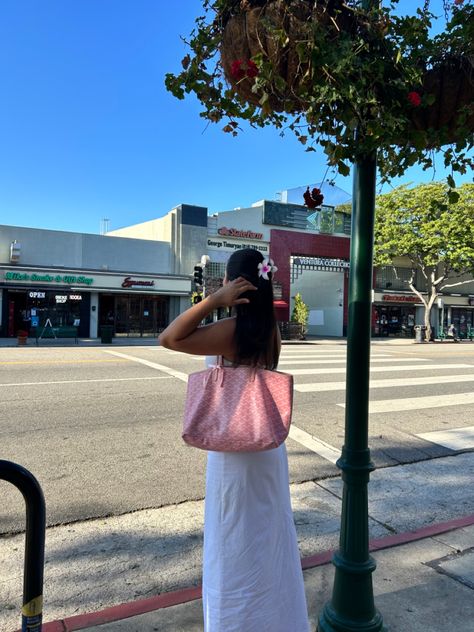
[[227, 248, 279, 369]]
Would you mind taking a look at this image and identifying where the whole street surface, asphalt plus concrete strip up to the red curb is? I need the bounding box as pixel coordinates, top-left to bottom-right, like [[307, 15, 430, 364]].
[[0, 341, 474, 632]]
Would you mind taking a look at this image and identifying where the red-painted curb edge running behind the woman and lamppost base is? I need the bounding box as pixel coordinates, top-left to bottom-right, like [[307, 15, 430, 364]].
[[39, 514, 474, 632]]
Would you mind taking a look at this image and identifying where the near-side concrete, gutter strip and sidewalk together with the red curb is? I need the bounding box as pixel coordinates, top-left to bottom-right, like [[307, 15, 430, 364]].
[[4, 452, 474, 632]]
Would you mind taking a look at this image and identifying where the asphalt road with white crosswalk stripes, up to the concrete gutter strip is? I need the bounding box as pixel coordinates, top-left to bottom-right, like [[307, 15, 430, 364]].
[[0, 342, 474, 533]]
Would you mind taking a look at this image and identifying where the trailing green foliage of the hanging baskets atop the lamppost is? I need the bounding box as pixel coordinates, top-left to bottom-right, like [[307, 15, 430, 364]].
[[165, 0, 474, 184]]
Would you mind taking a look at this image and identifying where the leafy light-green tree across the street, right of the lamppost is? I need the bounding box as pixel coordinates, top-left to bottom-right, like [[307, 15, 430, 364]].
[[374, 182, 474, 340]]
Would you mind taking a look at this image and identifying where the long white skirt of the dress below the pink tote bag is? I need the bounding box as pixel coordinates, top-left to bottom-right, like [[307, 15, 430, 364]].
[[203, 444, 310, 632]]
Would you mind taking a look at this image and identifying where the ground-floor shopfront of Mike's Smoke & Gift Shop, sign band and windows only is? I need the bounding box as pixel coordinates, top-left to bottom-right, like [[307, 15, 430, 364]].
[[0, 266, 190, 338]]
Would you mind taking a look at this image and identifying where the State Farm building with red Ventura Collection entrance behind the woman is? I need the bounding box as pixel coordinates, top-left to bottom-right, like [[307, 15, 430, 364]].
[[206, 200, 350, 336]]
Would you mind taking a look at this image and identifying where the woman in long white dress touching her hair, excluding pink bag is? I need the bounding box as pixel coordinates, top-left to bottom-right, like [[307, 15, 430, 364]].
[[160, 248, 309, 632]]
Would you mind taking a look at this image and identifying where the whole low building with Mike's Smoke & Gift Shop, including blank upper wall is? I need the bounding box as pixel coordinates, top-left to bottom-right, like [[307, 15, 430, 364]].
[[0, 209, 196, 338]]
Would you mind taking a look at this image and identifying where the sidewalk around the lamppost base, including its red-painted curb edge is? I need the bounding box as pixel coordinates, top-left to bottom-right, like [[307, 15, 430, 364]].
[[43, 516, 474, 632]]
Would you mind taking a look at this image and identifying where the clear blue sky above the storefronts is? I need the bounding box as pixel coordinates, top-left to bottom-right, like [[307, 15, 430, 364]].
[[0, 0, 471, 233]]
